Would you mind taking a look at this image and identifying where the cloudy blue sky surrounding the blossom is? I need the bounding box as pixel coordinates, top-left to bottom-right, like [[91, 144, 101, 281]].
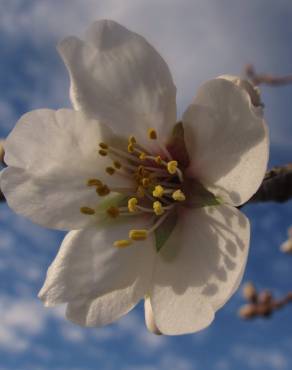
[[0, 0, 292, 370]]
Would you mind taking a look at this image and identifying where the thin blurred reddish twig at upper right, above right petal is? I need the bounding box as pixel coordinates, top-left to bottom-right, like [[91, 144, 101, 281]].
[[245, 64, 292, 86]]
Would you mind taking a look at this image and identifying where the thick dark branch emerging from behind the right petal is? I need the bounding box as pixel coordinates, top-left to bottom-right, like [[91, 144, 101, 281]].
[[245, 163, 292, 204]]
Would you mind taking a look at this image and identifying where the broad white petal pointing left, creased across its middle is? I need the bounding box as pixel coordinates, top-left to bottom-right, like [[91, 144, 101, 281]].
[[1, 109, 128, 229]]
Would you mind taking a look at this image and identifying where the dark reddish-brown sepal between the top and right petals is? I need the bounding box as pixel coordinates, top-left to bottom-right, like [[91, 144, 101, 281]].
[[166, 122, 190, 168]]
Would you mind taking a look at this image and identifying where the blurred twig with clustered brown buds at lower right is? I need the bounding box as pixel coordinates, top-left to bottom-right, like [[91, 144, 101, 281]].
[[239, 283, 292, 320]]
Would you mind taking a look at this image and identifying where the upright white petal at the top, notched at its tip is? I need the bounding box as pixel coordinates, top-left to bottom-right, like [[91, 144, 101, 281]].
[[58, 20, 176, 146]]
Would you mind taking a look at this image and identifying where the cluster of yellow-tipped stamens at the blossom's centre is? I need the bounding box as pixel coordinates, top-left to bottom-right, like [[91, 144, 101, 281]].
[[80, 128, 187, 248]]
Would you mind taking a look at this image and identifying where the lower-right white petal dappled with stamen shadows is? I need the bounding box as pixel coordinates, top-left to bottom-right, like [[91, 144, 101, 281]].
[[150, 206, 249, 335]]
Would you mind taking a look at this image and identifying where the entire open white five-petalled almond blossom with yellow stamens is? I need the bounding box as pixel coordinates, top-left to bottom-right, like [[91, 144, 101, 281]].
[[1, 21, 268, 335]]
